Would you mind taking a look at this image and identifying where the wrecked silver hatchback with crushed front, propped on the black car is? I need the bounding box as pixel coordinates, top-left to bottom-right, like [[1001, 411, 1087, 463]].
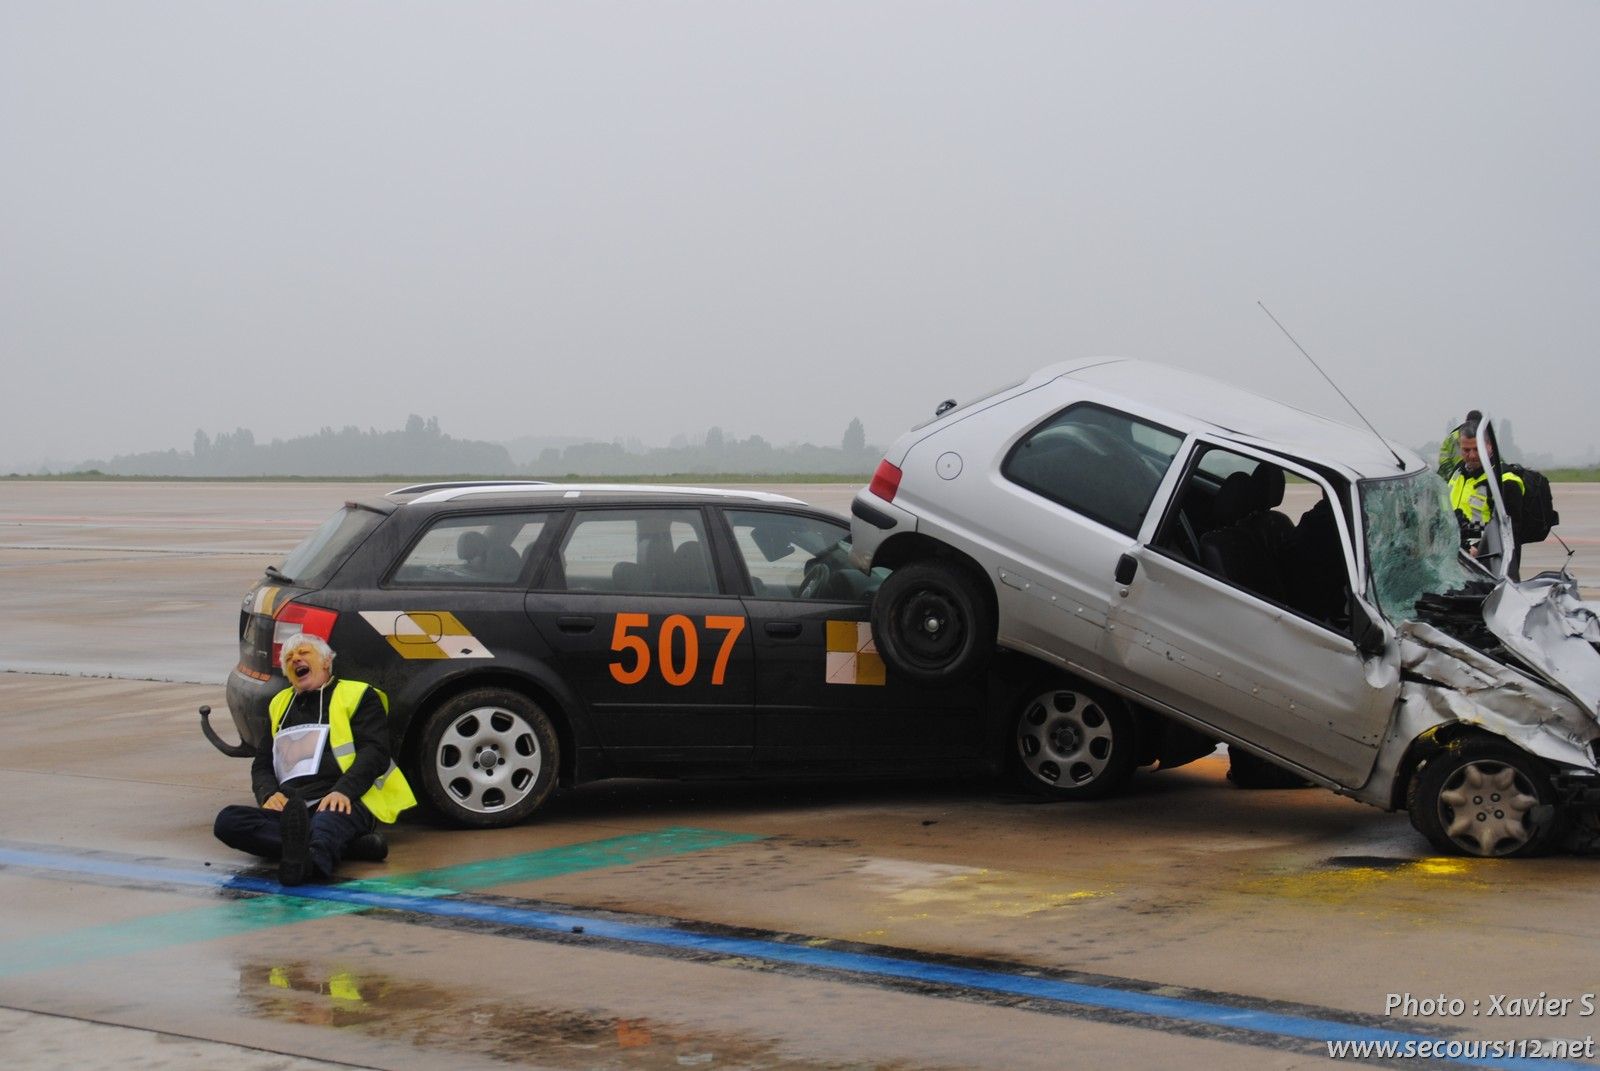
[[851, 359, 1600, 856]]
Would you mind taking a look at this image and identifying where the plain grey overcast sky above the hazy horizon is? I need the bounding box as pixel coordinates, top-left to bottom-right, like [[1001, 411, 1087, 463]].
[[0, 0, 1600, 471]]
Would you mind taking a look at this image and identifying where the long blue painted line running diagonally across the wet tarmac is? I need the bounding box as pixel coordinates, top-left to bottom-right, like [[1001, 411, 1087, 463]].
[[0, 848, 1594, 1071]]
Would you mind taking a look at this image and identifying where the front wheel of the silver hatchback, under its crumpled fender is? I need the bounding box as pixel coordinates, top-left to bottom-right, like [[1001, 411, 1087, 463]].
[[1406, 740, 1560, 858]]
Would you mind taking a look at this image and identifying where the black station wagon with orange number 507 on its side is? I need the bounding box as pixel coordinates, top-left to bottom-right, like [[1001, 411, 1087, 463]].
[[205, 483, 1213, 826]]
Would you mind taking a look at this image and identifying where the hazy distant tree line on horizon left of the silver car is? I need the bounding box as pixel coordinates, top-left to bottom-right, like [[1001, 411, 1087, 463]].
[[78, 413, 882, 477]]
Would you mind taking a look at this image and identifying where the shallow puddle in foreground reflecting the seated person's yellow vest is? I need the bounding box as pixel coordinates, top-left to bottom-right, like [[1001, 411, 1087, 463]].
[[238, 964, 928, 1071]]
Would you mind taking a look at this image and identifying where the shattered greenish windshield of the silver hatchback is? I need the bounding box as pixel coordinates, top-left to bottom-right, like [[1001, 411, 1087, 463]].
[[1360, 472, 1483, 623]]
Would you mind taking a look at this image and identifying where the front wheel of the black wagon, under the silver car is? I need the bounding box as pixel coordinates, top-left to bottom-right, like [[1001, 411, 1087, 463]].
[[1008, 677, 1139, 799]]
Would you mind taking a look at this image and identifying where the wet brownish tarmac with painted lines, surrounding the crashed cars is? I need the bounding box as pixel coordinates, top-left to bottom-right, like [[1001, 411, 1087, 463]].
[[0, 483, 1600, 1071]]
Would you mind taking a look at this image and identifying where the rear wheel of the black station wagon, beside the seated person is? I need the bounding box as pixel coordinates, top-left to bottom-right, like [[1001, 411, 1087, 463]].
[[418, 688, 560, 828]]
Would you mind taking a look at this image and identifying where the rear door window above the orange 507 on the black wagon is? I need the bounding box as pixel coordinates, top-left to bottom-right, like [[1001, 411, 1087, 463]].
[[549, 509, 717, 596]]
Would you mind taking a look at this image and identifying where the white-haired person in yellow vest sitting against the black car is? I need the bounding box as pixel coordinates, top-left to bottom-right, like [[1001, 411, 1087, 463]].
[[214, 632, 416, 885]]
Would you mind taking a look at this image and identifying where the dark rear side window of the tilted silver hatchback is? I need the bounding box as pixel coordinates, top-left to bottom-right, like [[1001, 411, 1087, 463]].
[[1000, 405, 1184, 535]]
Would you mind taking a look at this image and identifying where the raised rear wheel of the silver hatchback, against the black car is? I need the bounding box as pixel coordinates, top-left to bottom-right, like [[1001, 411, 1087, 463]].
[[872, 560, 995, 684]]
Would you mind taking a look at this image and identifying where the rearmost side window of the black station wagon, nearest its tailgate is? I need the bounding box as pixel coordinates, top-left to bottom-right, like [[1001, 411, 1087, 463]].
[[389, 512, 549, 588]]
